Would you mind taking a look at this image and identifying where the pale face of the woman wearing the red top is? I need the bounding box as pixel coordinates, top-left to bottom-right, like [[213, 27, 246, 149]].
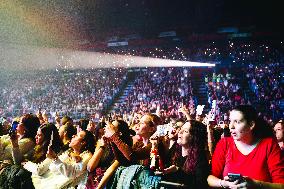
[[229, 110, 254, 141]]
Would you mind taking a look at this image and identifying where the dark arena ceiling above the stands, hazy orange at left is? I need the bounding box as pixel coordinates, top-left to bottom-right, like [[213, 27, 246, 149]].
[[0, 0, 283, 46]]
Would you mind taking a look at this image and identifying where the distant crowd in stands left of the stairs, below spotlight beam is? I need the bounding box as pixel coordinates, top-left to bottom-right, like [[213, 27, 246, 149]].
[[0, 68, 127, 118]]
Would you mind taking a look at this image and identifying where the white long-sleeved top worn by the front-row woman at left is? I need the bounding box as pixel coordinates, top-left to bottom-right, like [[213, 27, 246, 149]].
[[24, 151, 92, 189]]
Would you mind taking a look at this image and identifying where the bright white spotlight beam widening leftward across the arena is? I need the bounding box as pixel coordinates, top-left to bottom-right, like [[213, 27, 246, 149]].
[[0, 43, 215, 71]]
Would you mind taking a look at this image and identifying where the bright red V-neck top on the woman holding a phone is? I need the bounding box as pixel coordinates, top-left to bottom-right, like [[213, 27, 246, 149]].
[[212, 137, 284, 183]]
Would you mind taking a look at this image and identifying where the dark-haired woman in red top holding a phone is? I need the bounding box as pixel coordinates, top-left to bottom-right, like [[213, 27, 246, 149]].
[[207, 105, 284, 189]]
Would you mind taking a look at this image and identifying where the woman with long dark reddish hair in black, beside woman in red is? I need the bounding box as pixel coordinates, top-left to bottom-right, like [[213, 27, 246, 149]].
[[163, 120, 209, 188]]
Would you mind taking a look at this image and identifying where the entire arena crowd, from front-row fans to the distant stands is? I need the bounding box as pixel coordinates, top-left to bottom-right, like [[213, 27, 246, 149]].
[[0, 39, 284, 189]]
